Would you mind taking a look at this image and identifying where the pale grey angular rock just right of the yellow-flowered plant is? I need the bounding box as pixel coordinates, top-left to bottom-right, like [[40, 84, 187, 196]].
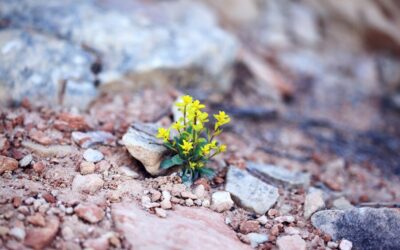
[[225, 166, 279, 214]]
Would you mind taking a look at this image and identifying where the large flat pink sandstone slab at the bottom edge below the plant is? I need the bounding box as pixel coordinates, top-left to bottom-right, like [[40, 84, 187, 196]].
[[111, 203, 251, 250]]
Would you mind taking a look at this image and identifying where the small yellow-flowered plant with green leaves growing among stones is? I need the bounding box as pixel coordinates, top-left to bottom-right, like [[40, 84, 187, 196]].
[[157, 95, 230, 183]]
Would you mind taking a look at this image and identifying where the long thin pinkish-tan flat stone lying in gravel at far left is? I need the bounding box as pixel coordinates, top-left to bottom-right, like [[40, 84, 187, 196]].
[[22, 141, 78, 157]]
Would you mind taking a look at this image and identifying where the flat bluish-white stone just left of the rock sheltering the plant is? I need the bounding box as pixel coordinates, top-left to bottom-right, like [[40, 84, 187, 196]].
[[71, 131, 116, 148]]
